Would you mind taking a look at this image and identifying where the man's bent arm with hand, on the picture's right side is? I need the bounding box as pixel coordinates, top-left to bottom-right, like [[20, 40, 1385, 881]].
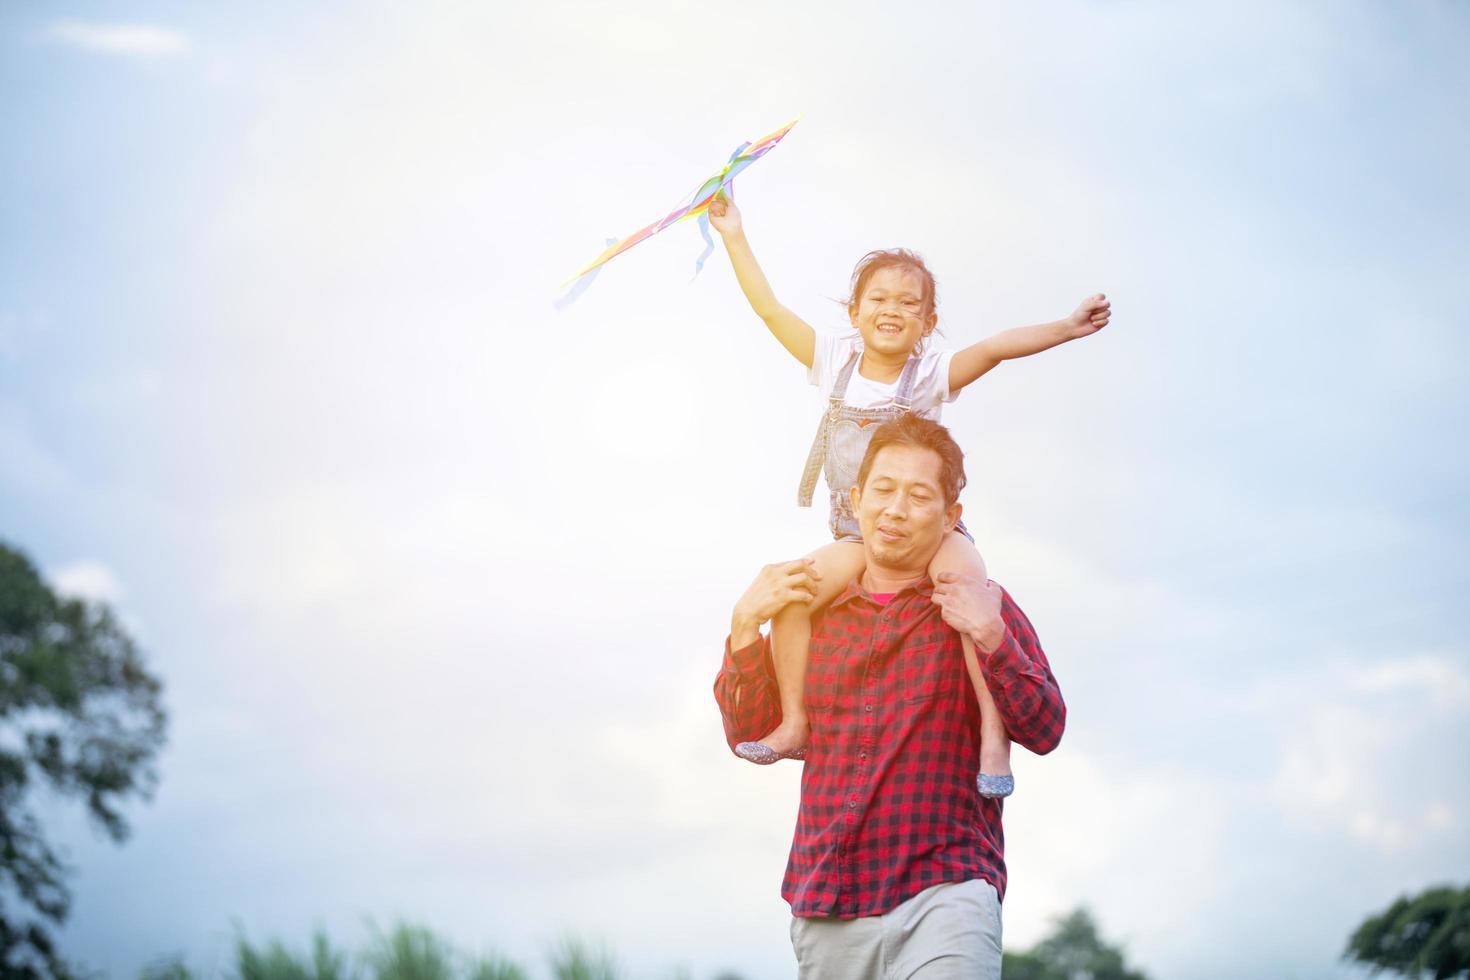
[[933, 572, 1067, 755]]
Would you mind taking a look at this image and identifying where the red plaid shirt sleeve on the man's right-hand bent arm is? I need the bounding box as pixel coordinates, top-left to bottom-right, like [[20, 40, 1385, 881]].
[[978, 592, 1067, 755]]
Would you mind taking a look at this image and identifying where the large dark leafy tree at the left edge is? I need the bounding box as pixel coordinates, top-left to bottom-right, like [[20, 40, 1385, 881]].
[[0, 544, 165, 980]]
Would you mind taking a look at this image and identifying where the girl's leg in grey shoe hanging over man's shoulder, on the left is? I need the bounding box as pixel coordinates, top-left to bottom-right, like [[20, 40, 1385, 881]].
[[736, 541, 864, 763]]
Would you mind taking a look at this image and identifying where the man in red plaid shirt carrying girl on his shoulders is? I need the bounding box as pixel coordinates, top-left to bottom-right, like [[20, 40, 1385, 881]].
[[714, 414, 1066, 980]]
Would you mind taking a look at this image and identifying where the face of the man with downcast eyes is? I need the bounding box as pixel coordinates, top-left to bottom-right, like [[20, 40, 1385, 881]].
[[853, 445, 960, 573]]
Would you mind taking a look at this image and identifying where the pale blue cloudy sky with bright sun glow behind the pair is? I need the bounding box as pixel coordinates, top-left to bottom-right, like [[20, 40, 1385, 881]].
[[0, 0, 1470, 980]]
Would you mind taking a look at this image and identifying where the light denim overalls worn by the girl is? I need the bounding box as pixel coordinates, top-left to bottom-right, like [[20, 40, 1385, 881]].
[[797, 348, 919, 541]]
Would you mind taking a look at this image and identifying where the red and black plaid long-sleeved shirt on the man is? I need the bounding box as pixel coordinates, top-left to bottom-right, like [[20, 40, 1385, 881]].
[[714, 579, 1067, 918]]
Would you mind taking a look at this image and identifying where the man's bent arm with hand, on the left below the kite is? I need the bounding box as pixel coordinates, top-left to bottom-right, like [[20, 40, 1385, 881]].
[[714, 558, 820, 752]]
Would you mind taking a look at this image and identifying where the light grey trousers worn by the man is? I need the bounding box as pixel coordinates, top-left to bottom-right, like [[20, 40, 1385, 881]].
[[791, 879, 1001, 980]]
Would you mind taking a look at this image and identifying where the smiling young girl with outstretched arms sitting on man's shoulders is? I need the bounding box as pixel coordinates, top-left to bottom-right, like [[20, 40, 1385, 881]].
[[709, 189, 1111, 796]]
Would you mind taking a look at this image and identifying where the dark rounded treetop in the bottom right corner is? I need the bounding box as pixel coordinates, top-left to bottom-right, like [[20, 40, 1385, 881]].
[[1342, 886, 1470, 980]]
